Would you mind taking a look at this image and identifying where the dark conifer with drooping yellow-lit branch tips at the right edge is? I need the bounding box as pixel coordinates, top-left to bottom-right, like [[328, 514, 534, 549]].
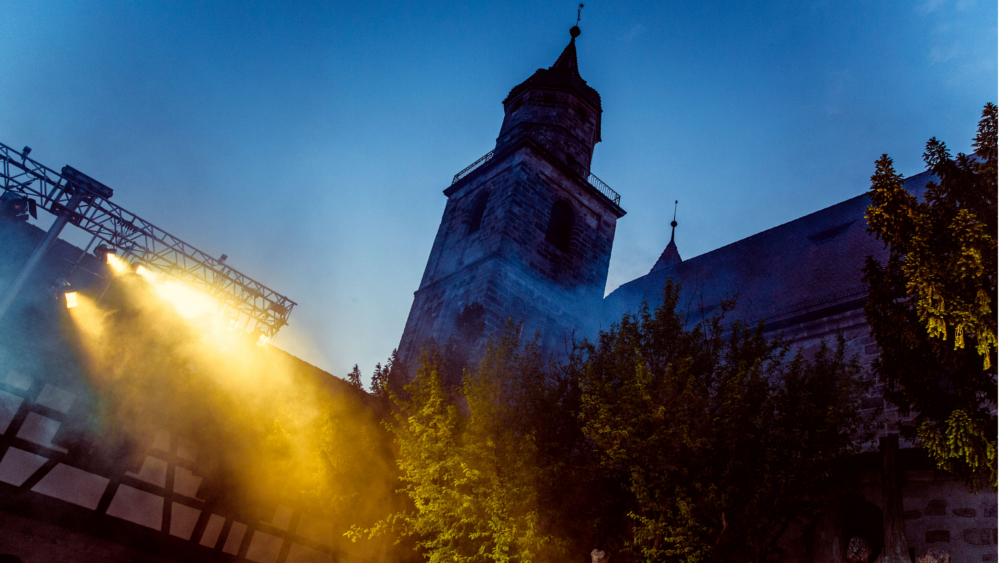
[[864, 104, 997, 489]]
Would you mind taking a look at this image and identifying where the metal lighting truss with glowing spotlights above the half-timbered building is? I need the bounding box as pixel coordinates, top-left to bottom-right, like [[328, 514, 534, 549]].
[[0, 143, 296, 338]]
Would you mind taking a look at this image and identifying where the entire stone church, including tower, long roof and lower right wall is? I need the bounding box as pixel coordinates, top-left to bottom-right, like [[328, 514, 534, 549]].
[[399, 27, 997, 563]]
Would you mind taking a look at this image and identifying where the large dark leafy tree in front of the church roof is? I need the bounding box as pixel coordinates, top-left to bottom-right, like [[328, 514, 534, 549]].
[[580, 281, 864, 562]]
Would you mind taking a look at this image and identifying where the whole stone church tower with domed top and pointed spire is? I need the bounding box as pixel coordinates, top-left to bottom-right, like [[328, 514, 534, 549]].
[[399, 26, 625, 365]]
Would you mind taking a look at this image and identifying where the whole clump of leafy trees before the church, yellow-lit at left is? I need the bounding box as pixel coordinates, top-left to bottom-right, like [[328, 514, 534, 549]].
[[362, 284, 872, 563]]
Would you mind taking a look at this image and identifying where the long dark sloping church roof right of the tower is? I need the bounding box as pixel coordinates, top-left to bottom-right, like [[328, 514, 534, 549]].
[[602, 172, 931, 329]]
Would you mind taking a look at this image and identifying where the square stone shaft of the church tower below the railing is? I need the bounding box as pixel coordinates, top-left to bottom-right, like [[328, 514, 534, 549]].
[[399, 139, 617, 363]]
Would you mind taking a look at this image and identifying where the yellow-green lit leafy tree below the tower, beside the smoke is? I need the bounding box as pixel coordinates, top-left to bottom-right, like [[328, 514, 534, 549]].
[[352, 323, 564, 563]]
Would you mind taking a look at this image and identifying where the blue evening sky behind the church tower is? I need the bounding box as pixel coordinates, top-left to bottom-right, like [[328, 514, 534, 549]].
[[0, 0, 998, 386]]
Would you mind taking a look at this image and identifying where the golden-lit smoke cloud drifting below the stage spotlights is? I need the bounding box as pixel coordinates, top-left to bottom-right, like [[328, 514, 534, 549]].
[[61, 272, 395, 552]]
